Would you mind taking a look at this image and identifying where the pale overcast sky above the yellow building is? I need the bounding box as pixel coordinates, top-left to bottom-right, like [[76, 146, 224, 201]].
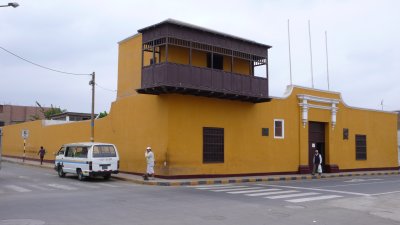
[[0, 0, 400, 112]]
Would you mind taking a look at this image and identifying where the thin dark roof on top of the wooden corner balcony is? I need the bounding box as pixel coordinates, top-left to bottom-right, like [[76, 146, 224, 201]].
[[138, 19, 272, 49]]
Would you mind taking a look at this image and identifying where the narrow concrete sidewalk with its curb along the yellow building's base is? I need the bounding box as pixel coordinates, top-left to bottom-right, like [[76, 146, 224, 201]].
[[2, 156, 400, 186]]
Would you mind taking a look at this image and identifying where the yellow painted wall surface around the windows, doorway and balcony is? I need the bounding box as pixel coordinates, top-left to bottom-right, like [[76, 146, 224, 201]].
[[2, 32, 398, 176]]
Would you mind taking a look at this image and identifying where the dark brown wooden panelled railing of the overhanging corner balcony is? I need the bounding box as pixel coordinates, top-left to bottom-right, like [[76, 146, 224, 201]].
[[137, 63, 270, 103]]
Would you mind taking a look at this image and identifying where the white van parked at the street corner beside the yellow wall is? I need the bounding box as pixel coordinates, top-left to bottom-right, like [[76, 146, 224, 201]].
[[54, 142, 119, 181]]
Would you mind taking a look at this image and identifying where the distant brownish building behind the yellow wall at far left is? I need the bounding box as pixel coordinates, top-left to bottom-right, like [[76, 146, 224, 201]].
[[0, 105, 49, 127]]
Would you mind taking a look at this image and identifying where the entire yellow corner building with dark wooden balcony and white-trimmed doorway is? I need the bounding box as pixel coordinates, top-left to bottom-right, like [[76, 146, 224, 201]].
[[0, 19, 399, 178]]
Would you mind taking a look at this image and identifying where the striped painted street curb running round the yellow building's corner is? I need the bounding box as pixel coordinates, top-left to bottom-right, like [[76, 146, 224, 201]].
[[2, 157, 400, 186]]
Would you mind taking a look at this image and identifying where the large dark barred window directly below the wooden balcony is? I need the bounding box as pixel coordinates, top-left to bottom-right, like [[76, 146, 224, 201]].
[[203, 127, 224, 163]]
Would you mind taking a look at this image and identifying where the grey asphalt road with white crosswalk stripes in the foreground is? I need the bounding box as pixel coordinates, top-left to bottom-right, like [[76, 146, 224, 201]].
[[0, 162, 400, 225]]
